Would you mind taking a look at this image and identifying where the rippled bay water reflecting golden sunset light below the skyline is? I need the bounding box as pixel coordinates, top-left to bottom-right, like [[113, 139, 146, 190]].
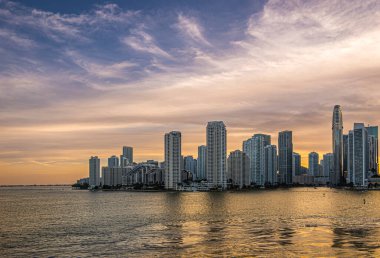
[[0, 187, 380, 257]]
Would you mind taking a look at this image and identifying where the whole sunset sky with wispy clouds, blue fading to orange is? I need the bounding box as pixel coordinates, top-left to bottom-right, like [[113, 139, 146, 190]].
[[0, 0, 380, 185]]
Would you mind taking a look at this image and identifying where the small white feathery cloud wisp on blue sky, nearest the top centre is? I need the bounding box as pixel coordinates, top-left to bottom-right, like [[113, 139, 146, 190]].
[[176, 14, 211, 46]]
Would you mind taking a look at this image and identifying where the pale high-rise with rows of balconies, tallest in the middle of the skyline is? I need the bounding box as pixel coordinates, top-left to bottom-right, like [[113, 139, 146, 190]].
[[206, 121, 227, 189]]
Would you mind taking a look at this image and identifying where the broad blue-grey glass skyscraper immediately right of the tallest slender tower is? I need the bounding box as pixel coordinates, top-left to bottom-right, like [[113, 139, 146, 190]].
[[348, 123, 369, 186]]
